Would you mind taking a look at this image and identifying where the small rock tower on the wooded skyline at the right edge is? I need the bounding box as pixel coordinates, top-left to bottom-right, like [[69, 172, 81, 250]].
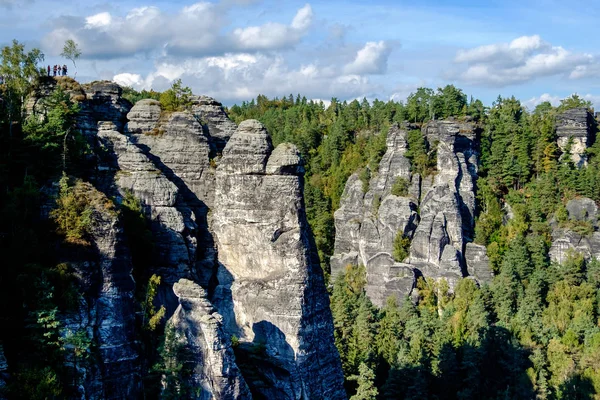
[[556, 107, 596, 167]]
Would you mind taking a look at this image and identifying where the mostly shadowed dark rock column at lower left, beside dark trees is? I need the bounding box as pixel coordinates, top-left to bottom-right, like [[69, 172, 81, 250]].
[[56, 182, 141, 399]]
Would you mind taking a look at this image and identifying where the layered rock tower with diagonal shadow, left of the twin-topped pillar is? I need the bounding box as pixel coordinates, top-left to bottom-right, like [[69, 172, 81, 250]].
[[126, 100, 216, 286]]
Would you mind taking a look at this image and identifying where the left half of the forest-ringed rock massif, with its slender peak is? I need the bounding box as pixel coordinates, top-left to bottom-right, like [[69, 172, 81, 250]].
[[331, 125, 418, 305]]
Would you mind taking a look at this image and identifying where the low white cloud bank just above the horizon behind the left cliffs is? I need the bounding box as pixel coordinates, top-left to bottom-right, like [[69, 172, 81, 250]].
[[113, 53, 374, 103]]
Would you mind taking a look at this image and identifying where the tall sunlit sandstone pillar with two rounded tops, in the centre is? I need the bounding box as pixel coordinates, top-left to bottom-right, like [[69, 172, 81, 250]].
[[213, 120, 345, 399]]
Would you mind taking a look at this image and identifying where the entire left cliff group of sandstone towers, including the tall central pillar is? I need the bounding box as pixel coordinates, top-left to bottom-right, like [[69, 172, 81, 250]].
[[18, 83, 345, 400]]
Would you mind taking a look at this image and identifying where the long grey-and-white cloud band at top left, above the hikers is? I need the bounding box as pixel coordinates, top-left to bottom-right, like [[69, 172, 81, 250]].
[[42, 0, 313, 59]]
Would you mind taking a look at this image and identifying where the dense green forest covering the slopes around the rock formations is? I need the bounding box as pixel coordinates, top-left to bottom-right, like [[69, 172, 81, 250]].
[[0, 38, 600, 400]]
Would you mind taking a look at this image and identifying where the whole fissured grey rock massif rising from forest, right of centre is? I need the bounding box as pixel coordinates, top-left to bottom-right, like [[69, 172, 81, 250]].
[[331, 120, 491, 306]]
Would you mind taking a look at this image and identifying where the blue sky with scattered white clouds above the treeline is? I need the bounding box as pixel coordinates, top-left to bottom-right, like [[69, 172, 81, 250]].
[[0, 0, 600, 109]]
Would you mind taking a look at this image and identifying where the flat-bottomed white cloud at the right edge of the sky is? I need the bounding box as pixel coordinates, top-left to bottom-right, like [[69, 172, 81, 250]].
[[448, 35, 600, 86]]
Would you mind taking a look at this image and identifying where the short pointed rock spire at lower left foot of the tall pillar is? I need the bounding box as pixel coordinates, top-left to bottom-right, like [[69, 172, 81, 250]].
[[166, 279, 252, 400]]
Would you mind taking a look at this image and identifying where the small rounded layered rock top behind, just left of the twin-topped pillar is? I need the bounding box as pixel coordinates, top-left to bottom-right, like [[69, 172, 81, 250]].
[[192, 96, 237, 153]]
